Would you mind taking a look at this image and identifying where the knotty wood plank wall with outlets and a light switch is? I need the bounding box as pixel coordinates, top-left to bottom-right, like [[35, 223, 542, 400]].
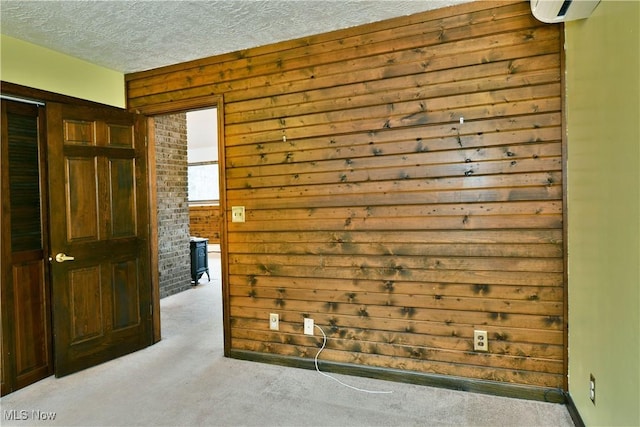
[[127, 1, 566, 388]]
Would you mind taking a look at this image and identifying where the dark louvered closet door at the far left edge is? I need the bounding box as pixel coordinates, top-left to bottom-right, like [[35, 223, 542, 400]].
[[0, 101, 53, 395]]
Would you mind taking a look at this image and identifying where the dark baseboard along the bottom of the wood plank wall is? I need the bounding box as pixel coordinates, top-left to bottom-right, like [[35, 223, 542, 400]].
[[229, 350, 564, 404]]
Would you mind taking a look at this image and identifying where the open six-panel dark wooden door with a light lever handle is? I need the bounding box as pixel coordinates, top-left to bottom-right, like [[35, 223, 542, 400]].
[[47, 103, 152, 376]]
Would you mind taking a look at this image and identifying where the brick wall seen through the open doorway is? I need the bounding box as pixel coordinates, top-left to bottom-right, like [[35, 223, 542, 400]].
[[155, 114, 191, 298]]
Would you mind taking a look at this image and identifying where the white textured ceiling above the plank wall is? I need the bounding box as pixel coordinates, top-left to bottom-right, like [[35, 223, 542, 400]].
[[0, 0, 469, 73]]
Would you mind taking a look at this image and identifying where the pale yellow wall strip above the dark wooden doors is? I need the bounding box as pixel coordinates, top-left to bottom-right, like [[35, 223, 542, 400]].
[[0, 35, 125, 108]]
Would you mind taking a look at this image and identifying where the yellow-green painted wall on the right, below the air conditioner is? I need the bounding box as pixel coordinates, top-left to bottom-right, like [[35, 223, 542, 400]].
[[565, 0, 640, 426]]
